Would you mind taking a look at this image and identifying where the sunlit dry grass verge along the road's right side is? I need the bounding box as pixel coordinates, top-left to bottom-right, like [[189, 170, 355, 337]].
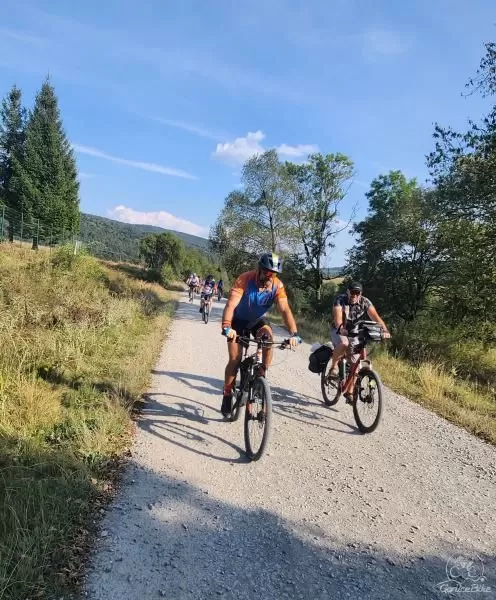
[[270, 313, 496, 444]]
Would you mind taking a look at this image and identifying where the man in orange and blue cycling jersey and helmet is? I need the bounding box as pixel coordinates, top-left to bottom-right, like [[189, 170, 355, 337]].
[[221, 253, 301, 417]]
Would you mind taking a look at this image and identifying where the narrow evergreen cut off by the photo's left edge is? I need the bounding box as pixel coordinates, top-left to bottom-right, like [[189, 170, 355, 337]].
[[0, 85, 26, 241]]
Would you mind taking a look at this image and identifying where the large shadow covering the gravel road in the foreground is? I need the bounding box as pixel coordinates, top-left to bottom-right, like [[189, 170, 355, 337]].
[[87, 466, 496, 600]]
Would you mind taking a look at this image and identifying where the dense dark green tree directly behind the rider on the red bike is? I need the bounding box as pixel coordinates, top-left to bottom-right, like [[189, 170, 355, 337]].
[[349, 171, 447, 323]]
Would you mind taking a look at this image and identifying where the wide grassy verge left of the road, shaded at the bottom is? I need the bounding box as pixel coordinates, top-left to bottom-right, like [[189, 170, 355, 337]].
[[0, 246, 174, 600]]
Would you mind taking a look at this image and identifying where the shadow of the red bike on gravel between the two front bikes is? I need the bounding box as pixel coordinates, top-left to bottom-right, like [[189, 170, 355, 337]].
[[271, 386, 361, 435]]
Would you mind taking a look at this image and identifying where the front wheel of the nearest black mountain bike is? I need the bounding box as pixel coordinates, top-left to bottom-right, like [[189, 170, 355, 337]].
[[245, 377, 272, 460]]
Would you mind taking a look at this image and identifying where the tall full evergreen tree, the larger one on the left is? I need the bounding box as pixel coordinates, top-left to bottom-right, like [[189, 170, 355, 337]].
[[14, 79, 79, 246]]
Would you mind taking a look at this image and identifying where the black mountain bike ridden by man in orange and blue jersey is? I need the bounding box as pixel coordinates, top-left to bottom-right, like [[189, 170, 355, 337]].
[[229, 336, 296, 460]]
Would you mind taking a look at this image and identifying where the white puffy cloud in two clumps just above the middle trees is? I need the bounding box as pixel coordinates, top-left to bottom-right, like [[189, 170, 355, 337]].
[[213, 130, 319, 165]]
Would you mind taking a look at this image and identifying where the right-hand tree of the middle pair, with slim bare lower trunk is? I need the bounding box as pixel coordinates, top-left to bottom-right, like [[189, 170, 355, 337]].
[[284, 153, 353, 301]]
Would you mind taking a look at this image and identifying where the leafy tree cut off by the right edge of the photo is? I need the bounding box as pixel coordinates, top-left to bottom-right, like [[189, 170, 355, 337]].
[[428, 43, 496, 322]]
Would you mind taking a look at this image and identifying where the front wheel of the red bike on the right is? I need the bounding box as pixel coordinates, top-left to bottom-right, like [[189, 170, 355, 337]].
[[353, 367, 382, 433]]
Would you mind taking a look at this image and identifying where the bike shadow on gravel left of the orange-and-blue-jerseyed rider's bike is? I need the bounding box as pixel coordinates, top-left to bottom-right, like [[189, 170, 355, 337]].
[[138, 393, 251, 463]]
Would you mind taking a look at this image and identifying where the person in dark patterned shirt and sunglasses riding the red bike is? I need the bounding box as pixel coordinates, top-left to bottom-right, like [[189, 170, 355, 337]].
[[328, 281, 391, 402]]
